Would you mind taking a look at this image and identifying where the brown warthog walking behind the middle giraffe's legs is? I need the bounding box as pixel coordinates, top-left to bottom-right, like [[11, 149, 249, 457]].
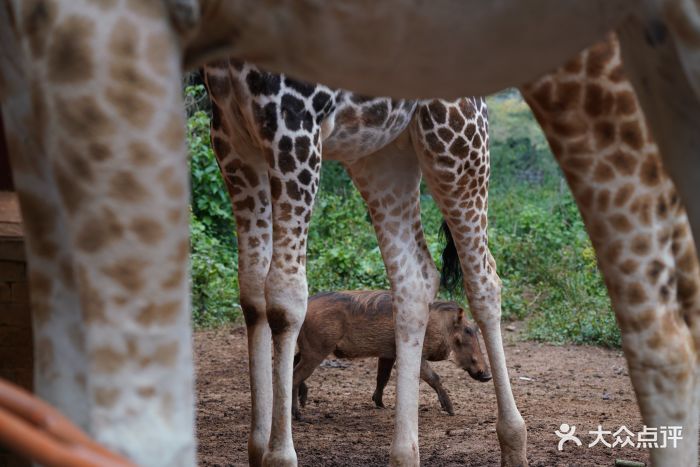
[[292, 290, 491, 419]]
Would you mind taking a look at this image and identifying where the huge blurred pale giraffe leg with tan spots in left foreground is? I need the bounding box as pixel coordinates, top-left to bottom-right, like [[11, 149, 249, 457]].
[[14, 2, 195, 466]]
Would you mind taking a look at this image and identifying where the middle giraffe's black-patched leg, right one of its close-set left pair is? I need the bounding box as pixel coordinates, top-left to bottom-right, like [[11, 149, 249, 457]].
[[205, 61, 333, 465]]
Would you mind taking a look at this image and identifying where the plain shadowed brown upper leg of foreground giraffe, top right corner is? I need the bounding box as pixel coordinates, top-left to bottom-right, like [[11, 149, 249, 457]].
[[618, 17, 700, 274]]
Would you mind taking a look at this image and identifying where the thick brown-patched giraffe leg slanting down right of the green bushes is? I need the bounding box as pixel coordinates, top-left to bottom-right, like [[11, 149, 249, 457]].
[[523, 37, 700, 466]]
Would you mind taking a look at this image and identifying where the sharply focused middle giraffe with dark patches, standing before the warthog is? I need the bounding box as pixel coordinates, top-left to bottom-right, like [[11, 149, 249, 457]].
[[203, 60, 526, 465]]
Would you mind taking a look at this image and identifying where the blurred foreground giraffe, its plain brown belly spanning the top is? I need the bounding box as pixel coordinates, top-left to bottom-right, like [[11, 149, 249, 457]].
[[0, 0, 700, 465]]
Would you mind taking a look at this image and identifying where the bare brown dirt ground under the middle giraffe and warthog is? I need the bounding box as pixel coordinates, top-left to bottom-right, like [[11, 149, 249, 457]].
[[195, 327, 648, 467]]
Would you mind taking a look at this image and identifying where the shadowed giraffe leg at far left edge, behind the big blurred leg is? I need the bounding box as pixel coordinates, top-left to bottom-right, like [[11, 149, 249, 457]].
[[0, 8, 90, 431]]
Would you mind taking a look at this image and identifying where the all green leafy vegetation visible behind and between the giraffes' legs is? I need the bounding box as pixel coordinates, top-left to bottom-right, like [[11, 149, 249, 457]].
[[188, 86, 620, 346]]
